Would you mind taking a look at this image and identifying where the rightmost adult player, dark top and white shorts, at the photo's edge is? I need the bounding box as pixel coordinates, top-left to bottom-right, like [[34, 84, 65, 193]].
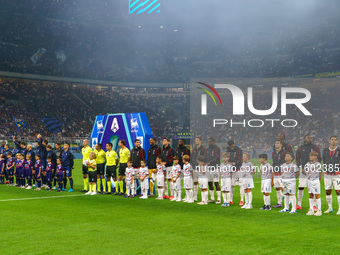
[[323, 136, 340, 215]]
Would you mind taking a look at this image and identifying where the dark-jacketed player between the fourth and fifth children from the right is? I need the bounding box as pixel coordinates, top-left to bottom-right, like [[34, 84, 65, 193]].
[[227, 140, 244, 206]]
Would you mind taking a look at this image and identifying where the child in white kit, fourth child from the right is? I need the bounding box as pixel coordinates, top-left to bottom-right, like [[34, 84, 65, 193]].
[[240, 152, 255, 209]]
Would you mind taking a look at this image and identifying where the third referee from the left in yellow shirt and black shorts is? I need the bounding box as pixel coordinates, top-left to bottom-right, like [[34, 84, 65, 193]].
[[106, 143, 118, 194]]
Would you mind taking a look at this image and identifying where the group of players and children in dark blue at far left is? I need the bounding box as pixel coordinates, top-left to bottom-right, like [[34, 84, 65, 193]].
[[0, 134, 74, 192]]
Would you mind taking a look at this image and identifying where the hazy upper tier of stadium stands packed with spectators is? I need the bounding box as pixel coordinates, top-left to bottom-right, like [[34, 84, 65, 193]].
[[0, 0, 340, 82]]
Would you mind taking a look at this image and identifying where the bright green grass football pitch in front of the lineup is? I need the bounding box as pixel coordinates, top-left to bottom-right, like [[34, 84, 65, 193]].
[[0, 160, 340, 254]]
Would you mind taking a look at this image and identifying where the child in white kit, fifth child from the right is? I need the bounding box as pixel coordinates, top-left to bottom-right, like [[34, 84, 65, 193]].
[[220, 152, 233, 207]]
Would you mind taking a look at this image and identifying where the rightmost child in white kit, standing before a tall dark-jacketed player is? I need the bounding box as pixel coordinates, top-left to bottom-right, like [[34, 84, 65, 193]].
[[302, 151, 322, 216]]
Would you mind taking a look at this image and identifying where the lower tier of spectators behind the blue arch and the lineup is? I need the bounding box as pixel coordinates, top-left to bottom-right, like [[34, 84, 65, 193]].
[[0, 81, 339, 150]]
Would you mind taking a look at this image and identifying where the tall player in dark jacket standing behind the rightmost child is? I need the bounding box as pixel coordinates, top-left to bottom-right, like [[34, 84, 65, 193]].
[[295, 134, 321, 210]]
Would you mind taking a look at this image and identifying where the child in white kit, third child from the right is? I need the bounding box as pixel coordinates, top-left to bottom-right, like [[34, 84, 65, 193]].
[[259, 154, 273, 211]]
